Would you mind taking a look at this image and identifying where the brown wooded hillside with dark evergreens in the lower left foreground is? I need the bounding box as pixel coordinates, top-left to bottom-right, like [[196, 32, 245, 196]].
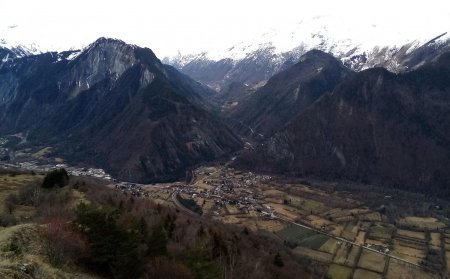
[[0, 171, 321, 278]]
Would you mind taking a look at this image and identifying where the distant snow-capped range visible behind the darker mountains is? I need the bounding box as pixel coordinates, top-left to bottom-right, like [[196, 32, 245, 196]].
[[163, 16, 450, 114]]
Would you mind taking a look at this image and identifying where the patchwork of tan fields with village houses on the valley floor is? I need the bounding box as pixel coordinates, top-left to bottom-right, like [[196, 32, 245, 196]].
[[143, 166, 450, 279]]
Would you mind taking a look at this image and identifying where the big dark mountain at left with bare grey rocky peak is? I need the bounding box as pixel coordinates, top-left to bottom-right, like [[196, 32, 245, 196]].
[[0, 38, 240, 182]]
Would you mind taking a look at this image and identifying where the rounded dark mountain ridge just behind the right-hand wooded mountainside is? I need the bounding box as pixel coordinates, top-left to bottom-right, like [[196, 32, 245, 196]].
[[227, 50, 351, 137]]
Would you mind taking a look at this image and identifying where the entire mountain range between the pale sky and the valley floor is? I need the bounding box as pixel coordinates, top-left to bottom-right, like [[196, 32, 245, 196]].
[[0, 33, 450, 195]]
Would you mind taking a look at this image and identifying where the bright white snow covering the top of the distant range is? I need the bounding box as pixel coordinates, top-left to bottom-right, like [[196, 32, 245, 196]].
[[164, 15, 450, 71]]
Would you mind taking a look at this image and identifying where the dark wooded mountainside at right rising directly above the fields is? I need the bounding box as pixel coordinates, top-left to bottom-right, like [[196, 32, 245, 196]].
[[238, 53, 450, 197]]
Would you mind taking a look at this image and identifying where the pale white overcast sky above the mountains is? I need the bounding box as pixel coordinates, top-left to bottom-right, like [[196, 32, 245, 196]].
[[0, 0, 450, 57]]
